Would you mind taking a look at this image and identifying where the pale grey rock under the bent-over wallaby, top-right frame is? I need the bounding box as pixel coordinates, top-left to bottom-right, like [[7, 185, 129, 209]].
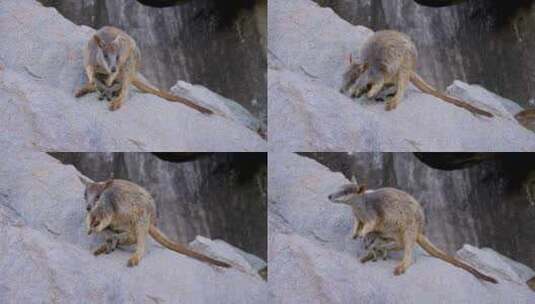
[[268, 0, 535, 151]]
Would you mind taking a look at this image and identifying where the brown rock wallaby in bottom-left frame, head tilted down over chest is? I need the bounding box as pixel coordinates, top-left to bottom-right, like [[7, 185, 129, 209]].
[[80, 177, 230, 267]]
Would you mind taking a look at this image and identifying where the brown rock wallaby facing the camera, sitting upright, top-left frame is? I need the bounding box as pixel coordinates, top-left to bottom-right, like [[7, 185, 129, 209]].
[[75, 26, 213, 114]]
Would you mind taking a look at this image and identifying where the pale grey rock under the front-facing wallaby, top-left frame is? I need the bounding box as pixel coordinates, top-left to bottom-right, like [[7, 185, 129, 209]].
[[0, 0, 266, 152]]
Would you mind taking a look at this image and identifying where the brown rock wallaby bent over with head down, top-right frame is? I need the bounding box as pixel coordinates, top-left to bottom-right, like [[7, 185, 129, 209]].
[[340, 30, 493, 117]]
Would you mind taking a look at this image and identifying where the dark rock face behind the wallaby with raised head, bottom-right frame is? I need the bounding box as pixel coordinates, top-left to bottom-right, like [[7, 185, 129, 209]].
[[305, 153, 535, 267]]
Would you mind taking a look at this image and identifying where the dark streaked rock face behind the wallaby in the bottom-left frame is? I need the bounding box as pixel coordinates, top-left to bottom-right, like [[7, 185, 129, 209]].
[[52, 153, 267, 259]]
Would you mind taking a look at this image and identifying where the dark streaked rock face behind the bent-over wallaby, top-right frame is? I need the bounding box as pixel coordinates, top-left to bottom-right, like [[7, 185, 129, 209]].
[[315, 0, 535, 107]]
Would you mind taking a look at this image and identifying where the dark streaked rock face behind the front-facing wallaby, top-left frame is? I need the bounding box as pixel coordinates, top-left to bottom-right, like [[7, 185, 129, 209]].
[[41, 0, 267, 122]]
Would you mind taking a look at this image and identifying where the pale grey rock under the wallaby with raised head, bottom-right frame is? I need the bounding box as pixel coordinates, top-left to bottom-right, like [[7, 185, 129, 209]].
[[268, 153, 535, 304]]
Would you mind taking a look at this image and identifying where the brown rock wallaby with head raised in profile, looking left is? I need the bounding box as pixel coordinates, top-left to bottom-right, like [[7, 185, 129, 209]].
[[328, 180, 497, 283]]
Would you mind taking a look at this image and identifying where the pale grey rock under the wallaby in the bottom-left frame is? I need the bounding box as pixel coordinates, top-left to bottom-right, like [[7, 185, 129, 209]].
[[0, 149, 267, 304]]
